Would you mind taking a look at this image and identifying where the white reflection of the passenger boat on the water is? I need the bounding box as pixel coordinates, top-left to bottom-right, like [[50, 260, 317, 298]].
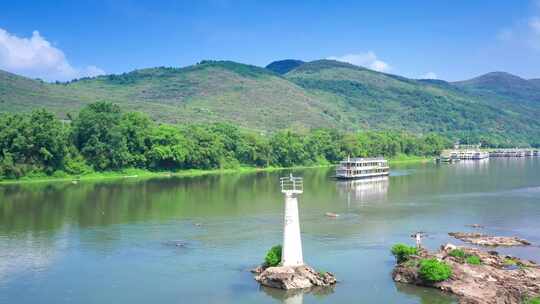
[[336, 176, 389, 207]]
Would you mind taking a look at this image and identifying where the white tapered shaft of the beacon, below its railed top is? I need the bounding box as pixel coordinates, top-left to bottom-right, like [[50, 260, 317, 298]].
[[281, 193, 304, 266]]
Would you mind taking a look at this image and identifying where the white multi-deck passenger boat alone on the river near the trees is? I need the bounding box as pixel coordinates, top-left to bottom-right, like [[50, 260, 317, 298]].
[[336, 157, 390, 179]]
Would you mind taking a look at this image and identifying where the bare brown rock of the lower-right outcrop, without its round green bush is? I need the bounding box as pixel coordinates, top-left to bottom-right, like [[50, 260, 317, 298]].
[[392, 245, 540, 304]]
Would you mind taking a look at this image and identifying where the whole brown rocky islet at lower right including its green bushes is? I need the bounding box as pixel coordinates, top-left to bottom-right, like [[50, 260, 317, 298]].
[[392, 244, 540, 304]]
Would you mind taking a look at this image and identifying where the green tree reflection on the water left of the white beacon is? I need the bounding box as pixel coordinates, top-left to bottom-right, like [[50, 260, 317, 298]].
[[0, 172, 288, 233]]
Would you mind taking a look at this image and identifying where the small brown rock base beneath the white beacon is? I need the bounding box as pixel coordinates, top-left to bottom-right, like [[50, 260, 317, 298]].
[[254, 265, 337, 290]]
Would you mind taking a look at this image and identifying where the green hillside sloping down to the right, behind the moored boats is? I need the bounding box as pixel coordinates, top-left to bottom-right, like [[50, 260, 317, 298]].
[[286, 60, 540, 141]]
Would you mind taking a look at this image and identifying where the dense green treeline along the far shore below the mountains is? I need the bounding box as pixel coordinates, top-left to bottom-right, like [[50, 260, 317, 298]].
[[0, 102, 451, 180]]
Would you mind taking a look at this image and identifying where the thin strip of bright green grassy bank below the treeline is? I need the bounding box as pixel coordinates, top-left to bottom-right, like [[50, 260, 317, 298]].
[[0, 155, 432, 185]]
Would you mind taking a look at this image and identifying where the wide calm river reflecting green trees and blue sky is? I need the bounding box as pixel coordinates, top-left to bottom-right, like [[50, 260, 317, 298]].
[[0, 158, 540, 304]]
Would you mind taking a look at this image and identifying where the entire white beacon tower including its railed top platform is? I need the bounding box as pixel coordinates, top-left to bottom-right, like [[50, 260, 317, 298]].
[[280, 173, 304, 266]]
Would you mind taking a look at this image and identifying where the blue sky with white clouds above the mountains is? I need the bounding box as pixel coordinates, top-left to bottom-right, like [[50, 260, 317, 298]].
[[0, 0, 540, 81]]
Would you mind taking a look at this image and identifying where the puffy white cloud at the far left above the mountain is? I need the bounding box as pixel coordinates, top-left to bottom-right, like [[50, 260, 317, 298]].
[[0, 28, 105, 81]]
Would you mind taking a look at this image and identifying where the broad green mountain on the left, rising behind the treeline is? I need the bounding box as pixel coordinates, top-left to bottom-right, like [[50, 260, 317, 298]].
[[0, 61, 342, 130]]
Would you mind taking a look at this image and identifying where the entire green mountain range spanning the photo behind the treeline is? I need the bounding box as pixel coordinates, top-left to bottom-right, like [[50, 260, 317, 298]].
[[0, 60, 540, 144]]
